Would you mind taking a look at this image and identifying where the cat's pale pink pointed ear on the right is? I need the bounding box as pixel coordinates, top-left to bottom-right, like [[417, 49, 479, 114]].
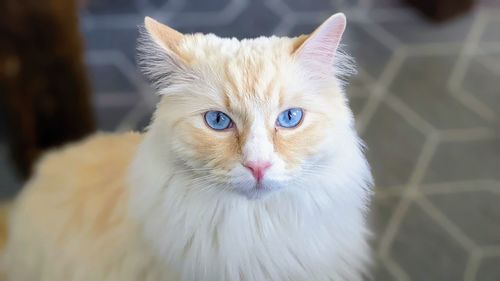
[[293, 13, 346, 76]]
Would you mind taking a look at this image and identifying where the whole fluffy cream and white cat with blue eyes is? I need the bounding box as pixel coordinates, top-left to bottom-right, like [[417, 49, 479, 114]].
[[2, 14, 371, 281]]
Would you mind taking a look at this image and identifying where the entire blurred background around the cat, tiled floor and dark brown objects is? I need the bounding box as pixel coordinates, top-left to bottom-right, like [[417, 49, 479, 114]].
[[0, 0, 500, 281]]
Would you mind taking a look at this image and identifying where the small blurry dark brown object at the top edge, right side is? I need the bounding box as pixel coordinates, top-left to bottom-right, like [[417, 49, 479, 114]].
[[406, 0, 475, 22]]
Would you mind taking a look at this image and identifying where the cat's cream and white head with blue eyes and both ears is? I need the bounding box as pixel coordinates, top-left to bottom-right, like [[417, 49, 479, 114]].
[[140, 14, 355, 198]]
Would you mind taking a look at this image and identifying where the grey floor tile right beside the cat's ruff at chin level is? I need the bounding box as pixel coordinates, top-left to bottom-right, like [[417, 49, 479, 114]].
[[362, 101, 425, 187]]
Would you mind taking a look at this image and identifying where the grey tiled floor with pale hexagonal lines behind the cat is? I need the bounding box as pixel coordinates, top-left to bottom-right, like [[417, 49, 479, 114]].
[[0, 0, 500, 281]]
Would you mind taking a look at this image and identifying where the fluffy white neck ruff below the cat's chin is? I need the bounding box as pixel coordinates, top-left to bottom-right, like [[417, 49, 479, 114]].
[[130, 127, 371, 281]]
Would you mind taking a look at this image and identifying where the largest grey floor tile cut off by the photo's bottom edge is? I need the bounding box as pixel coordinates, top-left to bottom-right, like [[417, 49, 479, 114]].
[[390, 202, 468, 281]]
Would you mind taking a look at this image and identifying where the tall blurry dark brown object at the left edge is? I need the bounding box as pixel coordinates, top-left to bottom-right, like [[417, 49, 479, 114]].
[[0, 0, 94, 177]]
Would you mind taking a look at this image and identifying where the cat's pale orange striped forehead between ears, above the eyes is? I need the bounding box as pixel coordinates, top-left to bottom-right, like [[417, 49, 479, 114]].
[[180, 35, 304, 111]]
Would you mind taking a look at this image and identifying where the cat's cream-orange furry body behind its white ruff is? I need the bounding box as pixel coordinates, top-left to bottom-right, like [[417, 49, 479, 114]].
[[2, 134, 168, 281]]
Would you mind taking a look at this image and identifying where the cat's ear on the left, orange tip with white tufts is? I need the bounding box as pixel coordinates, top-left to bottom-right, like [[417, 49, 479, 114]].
[[138, 17, 196, 94]]
